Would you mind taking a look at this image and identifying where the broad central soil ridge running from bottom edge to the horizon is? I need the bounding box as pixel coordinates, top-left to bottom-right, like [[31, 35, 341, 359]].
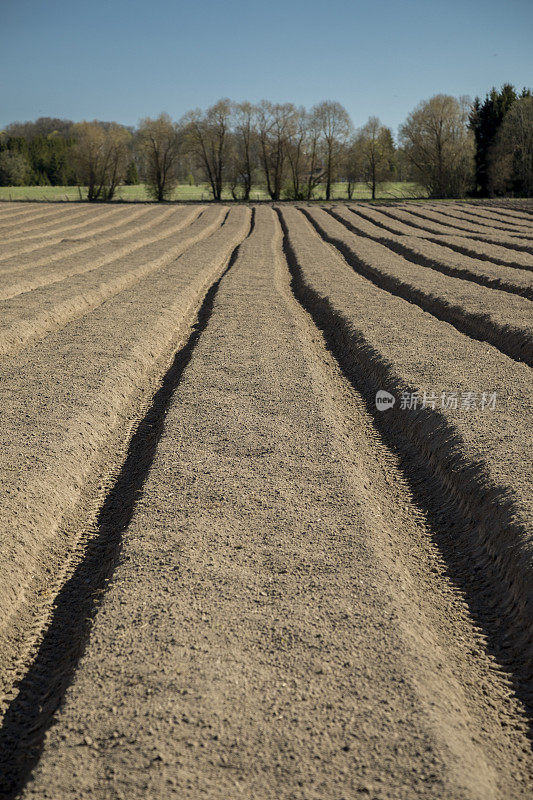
[[10, 207, 527, 800]]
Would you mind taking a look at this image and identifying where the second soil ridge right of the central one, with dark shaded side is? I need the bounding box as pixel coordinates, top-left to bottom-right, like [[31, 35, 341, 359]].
[[301, 208, 533, 366]]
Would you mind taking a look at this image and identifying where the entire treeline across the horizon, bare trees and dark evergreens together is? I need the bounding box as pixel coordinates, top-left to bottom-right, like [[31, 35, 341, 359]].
[[0, 85, 533, 200]]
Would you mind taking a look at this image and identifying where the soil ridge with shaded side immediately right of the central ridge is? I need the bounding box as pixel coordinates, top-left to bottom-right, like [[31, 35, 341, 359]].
[[278, 203, 533, 684]]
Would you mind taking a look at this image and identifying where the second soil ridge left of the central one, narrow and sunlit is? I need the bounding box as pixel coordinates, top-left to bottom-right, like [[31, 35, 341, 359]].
[[0, 208, 222, 355]]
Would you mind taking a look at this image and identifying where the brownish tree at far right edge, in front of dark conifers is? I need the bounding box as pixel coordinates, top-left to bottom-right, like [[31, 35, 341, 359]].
[[489, 96, 533, 197]]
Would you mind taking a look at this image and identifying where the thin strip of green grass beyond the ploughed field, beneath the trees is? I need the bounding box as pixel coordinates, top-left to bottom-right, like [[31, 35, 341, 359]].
[[0, 181, 425, 202]]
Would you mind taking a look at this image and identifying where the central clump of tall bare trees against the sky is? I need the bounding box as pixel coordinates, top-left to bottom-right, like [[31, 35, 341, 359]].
[[181, 100, 394, 200]]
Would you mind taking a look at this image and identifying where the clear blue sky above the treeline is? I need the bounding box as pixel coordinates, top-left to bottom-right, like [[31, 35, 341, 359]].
[[0, 0, 533, 130]]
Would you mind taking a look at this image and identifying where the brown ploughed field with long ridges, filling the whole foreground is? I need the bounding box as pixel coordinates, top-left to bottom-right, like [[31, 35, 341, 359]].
[[0, 197, 533, 800]]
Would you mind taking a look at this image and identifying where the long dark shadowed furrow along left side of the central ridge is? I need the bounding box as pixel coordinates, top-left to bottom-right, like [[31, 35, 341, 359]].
[[0, 209, 255, 800]]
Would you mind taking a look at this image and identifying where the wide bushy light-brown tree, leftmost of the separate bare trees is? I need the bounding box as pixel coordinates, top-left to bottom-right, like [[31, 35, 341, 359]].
[[71, 120, 132, 200]]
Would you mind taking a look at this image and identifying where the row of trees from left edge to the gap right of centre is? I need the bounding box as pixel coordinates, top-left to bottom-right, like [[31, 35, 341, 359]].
[[0, 99, 395, 200]]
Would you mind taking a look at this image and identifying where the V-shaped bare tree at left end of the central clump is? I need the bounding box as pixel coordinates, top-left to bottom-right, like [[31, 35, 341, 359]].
[[183, 99, 233, 201]]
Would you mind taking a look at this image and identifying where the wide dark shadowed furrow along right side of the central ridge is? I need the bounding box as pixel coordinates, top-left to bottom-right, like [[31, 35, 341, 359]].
[[276, 208, 533, 738]]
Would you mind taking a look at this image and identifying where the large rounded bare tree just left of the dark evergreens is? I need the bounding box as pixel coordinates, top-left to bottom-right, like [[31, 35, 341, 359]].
[[400, 94, 474, 197]]
